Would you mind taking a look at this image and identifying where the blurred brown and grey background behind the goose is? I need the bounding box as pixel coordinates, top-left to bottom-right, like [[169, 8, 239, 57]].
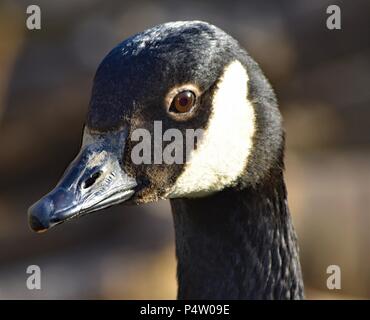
[[0, 0, 370, 299]]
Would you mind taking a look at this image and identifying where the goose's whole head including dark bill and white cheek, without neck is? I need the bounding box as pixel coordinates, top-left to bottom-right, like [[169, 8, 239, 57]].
[[28, 21, 283, 232]]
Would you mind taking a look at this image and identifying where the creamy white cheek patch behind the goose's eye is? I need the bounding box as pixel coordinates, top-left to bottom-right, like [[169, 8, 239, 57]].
[[167, 61, 255, 198]]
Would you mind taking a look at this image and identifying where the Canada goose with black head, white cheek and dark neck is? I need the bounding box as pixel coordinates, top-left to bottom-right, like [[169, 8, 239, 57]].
[[28, 21, 303, 299]]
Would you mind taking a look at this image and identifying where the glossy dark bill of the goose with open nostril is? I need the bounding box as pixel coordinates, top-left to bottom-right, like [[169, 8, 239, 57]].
[[28, 130, 137, 232]]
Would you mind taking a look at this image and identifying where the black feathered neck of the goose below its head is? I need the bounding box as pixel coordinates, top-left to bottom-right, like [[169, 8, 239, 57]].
[[171, 176, 303, 299]]
